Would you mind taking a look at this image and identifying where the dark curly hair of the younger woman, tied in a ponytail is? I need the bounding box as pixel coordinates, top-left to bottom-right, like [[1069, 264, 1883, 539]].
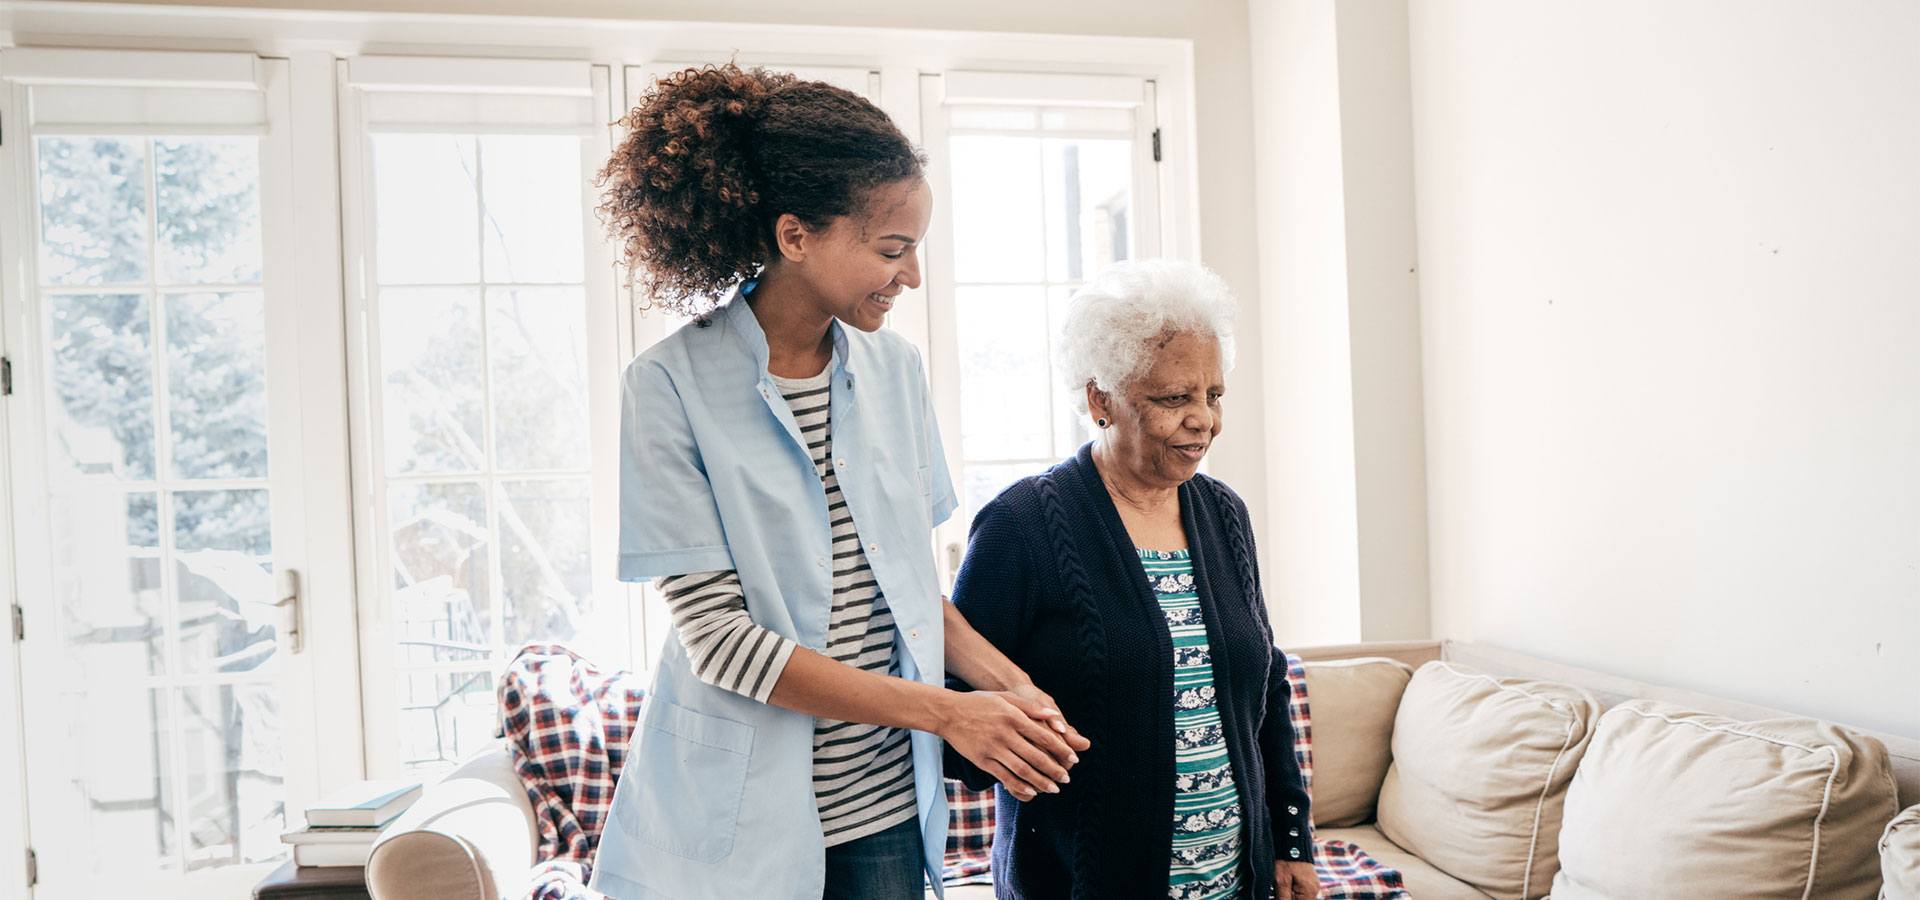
[[595, 63, 925, 315]]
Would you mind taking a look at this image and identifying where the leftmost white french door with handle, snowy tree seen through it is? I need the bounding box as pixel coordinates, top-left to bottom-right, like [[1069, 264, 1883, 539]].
[[0, 50, 357, 900]]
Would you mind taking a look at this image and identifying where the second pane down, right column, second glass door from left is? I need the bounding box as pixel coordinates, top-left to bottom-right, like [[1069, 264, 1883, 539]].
[[488, 288, 591, 470]]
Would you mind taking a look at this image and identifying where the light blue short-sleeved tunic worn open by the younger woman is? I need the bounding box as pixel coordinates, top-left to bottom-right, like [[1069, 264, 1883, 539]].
[[593, 282, 956, 900]]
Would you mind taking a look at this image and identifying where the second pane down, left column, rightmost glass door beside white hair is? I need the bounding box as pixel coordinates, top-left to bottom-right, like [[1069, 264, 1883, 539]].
[[954, 288, 1054, 461]]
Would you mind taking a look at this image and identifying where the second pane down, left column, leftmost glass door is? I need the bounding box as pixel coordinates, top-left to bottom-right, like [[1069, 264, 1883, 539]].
[[46, 294, 154, 480]]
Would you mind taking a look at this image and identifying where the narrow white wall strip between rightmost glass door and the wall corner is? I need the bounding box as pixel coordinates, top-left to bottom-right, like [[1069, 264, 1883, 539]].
[[1250, 0, 1359, 645]]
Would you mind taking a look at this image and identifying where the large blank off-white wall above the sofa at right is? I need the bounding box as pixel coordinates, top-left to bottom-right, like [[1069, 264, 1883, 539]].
[[1411, 0, 1920, 735]]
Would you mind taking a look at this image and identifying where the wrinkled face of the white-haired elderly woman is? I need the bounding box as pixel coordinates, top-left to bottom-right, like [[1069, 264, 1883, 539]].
[[1087, 332, 1227, 487]]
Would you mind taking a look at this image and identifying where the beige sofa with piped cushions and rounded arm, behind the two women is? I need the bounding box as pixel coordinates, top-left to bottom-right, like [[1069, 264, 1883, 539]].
[[367, 641, 1920, 900]]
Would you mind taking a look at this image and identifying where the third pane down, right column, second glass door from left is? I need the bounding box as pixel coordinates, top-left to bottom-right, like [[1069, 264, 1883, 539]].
[[499, 478, 595, 647]]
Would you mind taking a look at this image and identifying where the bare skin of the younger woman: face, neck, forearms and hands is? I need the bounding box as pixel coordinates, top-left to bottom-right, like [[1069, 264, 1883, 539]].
[[747, 178, 1091, 800]]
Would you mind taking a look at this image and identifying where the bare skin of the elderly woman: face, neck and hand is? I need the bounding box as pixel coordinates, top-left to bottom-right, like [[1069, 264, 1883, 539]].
[[1087, 332, 1319, 900]]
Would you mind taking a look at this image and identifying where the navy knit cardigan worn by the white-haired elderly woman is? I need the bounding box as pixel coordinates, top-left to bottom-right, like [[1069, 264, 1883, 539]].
[[947, 445, 1313, 900]]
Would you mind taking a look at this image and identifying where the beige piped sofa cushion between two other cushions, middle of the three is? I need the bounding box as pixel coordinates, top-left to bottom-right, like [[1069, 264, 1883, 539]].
[[1379, 662, 1599, 900]]
